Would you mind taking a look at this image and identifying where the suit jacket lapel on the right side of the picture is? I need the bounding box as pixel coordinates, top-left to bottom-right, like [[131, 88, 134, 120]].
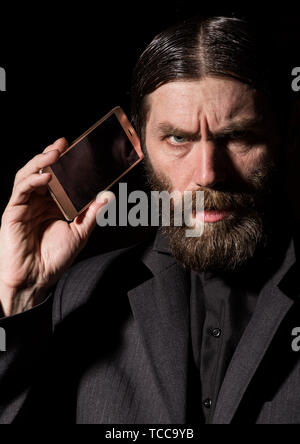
[[212, 240, 295, 424]]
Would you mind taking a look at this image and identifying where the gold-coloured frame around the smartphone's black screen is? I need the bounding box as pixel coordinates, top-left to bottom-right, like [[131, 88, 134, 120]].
[[43, 106, 144, 222]]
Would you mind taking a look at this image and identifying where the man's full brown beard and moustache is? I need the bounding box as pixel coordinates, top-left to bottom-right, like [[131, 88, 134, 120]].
[[144, 149, 279, 272]]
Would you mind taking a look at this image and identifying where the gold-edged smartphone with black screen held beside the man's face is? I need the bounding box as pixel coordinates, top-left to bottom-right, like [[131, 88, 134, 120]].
[[43, 106, 143, 221]]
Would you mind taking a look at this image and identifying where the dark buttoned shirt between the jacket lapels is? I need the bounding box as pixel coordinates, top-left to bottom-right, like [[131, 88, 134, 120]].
[[190, 271, 258, 422]]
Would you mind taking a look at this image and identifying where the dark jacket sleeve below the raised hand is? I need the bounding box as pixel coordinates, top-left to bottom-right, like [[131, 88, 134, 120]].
[[0, 275, 70, 424]]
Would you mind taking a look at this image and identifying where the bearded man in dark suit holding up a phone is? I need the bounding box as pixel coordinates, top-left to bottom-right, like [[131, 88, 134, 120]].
[[0, 17, 300, 424]]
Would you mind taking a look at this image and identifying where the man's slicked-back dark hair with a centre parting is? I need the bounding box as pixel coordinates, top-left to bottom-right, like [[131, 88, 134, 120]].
[[131, 17, 290, 145]]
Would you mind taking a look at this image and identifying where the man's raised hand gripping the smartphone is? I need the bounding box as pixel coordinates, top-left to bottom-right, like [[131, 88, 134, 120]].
[[0, 138, 105, 316]]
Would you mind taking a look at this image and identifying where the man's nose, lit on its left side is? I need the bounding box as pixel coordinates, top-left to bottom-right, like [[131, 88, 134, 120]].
[[192, 140, 226, 188]]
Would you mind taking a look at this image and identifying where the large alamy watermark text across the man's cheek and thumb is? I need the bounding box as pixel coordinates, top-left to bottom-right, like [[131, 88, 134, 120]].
[[97, 183, 204, 237]]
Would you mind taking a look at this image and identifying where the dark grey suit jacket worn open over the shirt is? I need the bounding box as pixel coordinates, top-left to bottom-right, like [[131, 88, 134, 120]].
[[0, 227, 300, 424]]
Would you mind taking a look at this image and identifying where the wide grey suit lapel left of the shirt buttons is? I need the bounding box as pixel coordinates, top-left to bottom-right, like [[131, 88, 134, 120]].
[[128, 252, 189, 423]]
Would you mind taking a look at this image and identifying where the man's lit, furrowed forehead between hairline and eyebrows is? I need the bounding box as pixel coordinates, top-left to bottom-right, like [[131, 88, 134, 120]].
[[148, 77, 256, 129]]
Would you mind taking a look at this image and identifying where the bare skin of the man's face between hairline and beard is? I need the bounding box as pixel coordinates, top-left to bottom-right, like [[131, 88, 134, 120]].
[[146, 77, 276, 192]]
